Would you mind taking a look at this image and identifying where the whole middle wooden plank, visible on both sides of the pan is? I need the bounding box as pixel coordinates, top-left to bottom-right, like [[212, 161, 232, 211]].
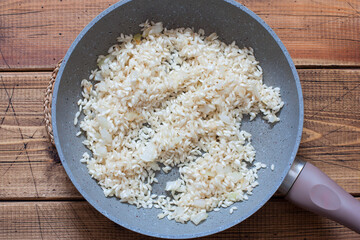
[[0, 69, 360, 200]]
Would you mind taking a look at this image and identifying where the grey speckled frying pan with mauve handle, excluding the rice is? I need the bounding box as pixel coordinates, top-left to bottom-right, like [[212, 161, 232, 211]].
[[52, 0, 360, 238]]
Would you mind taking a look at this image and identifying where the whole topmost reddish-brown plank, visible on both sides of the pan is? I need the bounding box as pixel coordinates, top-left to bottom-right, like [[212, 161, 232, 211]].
[[0, 0, 360, 70]]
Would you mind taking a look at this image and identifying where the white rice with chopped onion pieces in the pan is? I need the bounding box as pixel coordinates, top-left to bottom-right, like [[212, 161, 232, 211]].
[[74, 22, 283, 224]]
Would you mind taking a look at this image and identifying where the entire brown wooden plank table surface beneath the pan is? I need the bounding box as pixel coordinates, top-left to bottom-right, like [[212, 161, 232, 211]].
[[0, 0, 360, 239]]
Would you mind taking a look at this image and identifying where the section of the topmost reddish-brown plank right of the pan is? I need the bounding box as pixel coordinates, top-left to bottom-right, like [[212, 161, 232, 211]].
[[240, 0, 360, 66]]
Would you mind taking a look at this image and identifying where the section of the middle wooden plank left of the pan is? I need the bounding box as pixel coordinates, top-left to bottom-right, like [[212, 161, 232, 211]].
[[0, 73, 81, 199]]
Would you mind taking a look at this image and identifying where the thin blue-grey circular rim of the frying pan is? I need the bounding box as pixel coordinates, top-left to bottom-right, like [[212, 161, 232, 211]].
[[51, 0, 304, 239]]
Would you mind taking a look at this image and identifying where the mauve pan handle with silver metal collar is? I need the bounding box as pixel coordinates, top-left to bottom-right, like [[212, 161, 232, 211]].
[[279, 159, 360, 233]]
